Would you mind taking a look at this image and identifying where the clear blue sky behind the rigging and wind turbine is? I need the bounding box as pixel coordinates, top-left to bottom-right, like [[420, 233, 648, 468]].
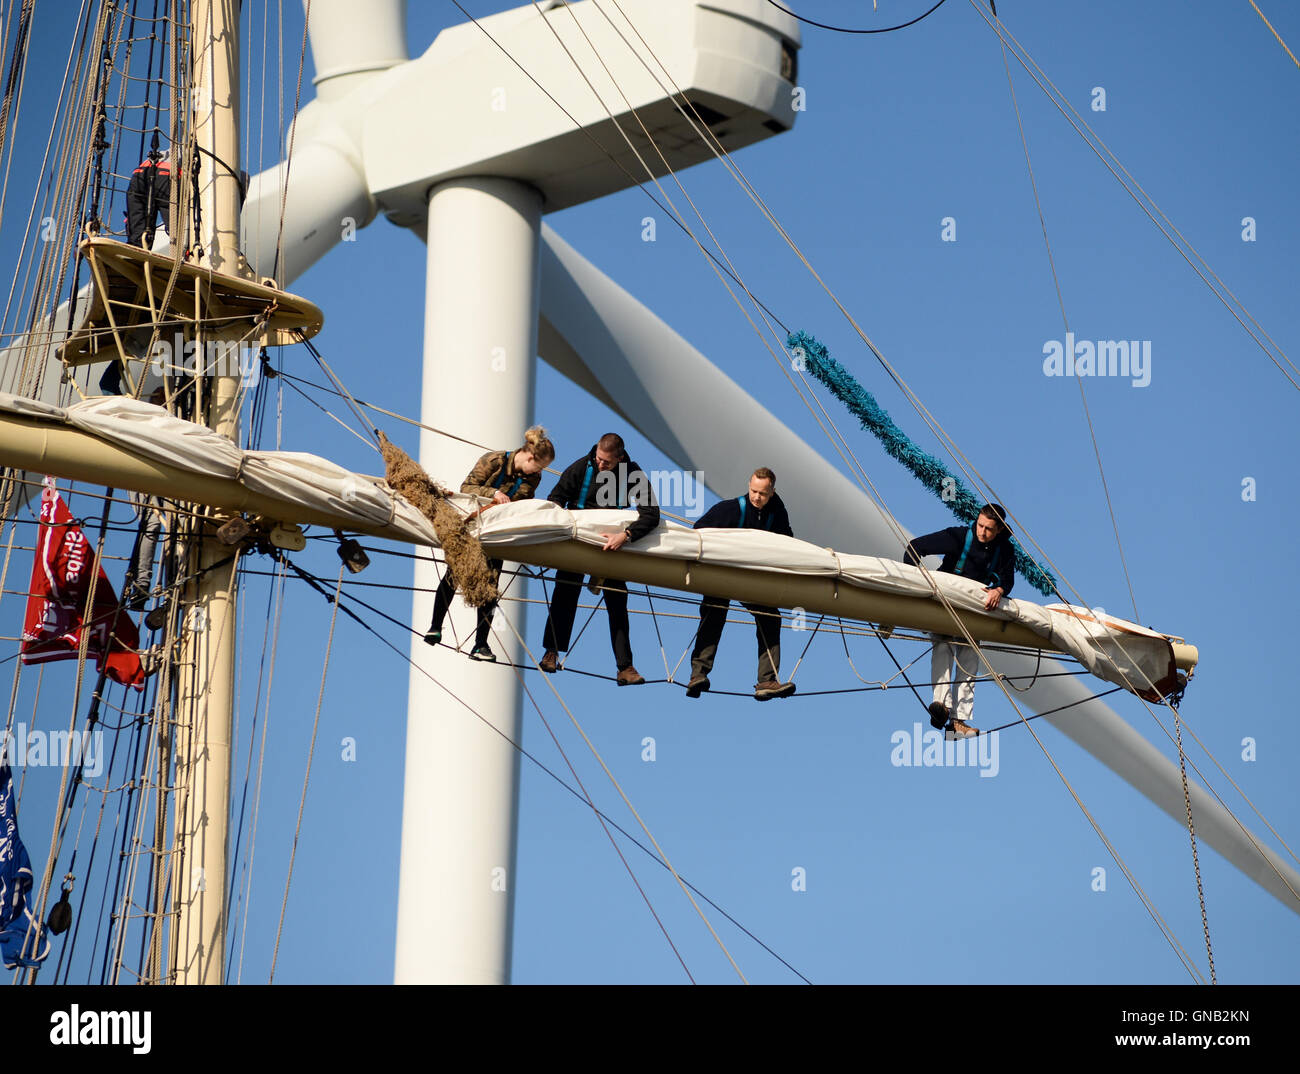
[[0, 0, 1300, 983]]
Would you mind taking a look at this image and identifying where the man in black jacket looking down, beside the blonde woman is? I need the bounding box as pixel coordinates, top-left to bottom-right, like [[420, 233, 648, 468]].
[[540, 433, 659, 687]]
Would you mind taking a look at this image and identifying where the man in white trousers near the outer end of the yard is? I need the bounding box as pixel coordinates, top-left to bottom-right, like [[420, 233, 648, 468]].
[[904, 503, 1015, 739]]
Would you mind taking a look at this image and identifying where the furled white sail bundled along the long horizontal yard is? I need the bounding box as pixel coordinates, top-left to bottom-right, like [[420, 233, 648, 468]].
[[0, 394, 1187, 698]]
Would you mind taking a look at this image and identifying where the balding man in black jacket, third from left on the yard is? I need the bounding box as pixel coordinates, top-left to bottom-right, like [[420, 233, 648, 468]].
[[686, 467, 794, 701]]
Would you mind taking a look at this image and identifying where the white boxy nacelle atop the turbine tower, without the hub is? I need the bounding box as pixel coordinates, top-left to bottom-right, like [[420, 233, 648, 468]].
[[363, 0, 798, 226]]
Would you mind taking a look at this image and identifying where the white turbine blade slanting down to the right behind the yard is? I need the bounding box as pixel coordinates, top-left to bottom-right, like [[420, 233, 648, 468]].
[[538, 224, 1300, 913]]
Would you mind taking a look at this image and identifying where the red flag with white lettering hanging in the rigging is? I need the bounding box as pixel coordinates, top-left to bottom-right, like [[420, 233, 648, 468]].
[[20, 477, 144, 689]]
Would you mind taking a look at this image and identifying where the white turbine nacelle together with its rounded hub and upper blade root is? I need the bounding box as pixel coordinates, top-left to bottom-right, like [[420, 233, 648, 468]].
[[243, 0, 800, 285]]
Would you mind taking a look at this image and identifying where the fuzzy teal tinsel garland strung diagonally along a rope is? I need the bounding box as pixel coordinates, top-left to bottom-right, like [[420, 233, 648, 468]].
[[785, 332, 1056, 597]]
